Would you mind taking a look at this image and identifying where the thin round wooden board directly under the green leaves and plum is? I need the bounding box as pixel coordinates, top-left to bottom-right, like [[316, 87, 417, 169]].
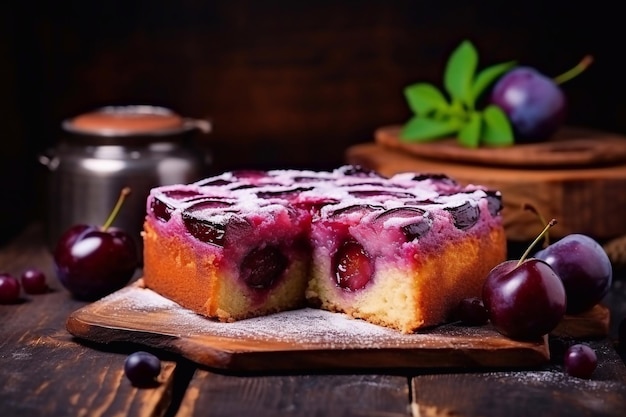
[[374, 126, 626, 168]]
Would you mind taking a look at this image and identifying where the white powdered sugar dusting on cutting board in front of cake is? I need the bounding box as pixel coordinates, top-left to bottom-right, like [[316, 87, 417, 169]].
[[94, 281, 532, 349]]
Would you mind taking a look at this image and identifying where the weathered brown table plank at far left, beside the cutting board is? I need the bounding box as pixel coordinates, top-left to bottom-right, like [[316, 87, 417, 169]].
[[0, 224, 176, 417]]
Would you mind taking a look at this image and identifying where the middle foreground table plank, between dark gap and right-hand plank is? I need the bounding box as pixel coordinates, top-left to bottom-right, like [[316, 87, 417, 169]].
[[177, 370, 411, 417]]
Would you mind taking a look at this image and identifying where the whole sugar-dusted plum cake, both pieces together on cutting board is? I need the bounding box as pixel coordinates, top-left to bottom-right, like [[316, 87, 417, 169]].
[[143, 166, 506, 333]]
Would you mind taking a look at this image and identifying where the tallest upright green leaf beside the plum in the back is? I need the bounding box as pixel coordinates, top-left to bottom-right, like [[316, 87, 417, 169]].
[[444, 40, 478, 106]]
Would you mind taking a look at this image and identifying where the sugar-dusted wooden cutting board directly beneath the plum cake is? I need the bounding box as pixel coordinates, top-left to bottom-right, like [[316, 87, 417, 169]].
[[67, 280, 604, 371]]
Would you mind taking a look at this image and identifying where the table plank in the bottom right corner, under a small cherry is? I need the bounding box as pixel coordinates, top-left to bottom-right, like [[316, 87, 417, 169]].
[[412, 341, 626, 417]]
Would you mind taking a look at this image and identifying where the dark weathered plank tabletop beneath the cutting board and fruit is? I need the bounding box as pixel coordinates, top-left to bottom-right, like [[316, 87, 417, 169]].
[[0, 225, 626, 417]]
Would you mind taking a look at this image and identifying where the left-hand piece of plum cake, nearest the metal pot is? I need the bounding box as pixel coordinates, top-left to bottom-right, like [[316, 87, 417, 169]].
[[143, 174, 310, 321]]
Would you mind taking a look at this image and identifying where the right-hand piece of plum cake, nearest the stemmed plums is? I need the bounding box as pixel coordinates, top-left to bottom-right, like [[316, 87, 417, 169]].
[[307, 172, 506, 333]]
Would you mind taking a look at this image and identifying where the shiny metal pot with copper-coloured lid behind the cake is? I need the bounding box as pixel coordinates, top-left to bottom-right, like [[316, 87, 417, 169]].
[[39, 105, 211, 259]]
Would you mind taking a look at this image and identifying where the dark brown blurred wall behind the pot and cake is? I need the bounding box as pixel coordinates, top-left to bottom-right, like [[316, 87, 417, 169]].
[[0, 0, 626, 241]]
